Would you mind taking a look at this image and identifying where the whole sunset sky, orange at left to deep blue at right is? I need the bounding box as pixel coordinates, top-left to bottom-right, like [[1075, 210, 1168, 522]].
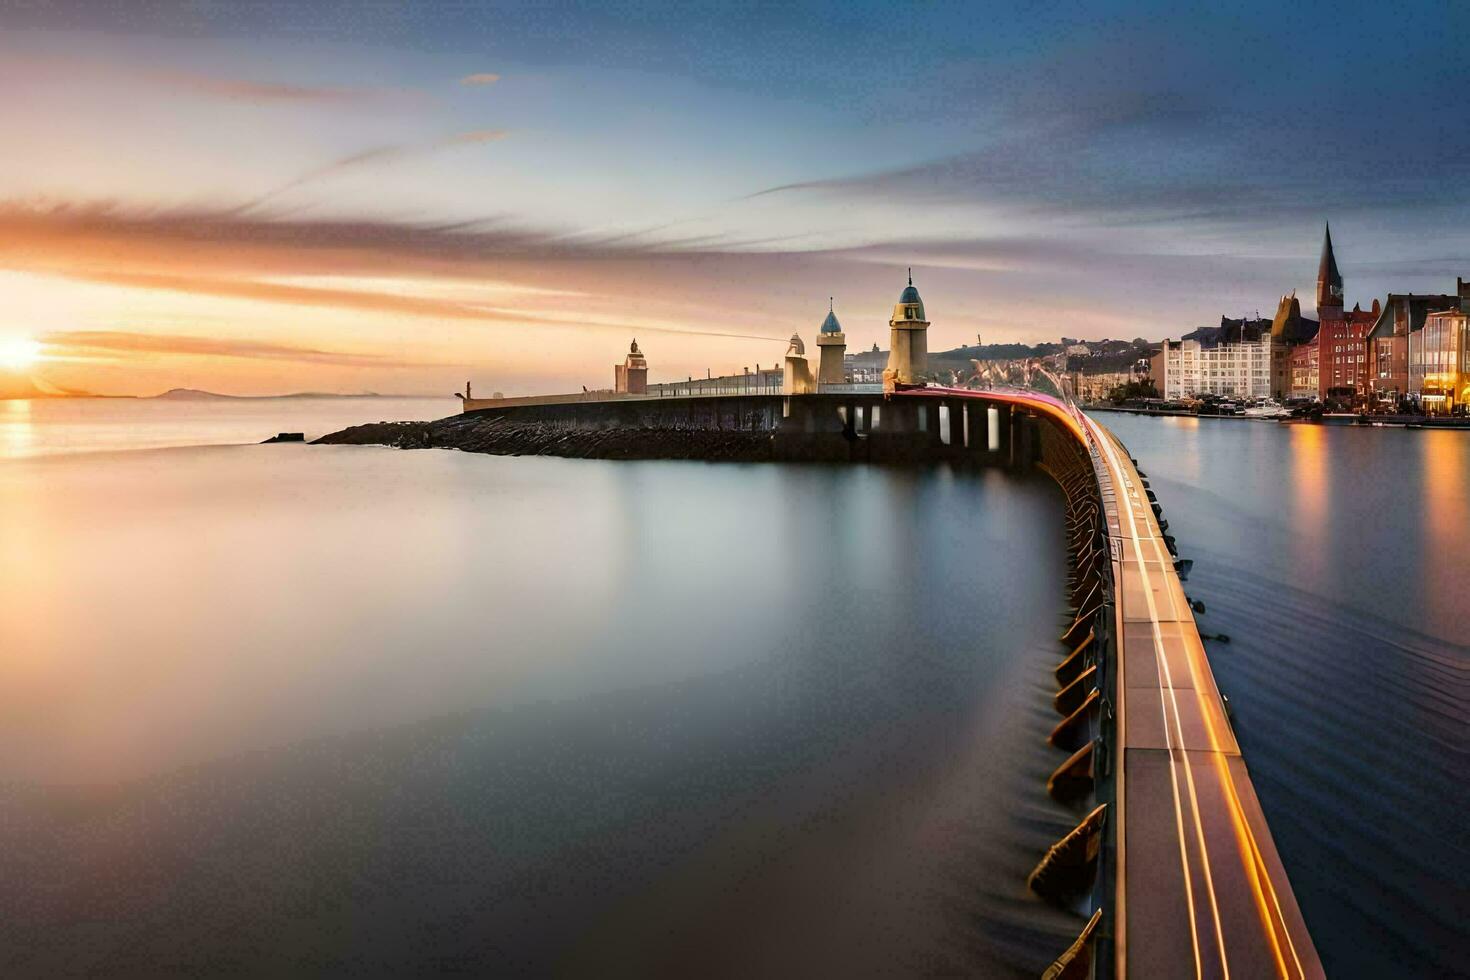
[[0, 0, 1470, 394]]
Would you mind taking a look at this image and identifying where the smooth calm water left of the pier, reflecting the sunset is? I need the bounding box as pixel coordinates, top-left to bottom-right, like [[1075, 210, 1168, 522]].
[[0, 401, 1080, 976]]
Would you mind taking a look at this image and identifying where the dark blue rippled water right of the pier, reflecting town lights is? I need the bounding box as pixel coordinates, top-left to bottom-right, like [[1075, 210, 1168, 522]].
[[1098, 413, 1470, 977]]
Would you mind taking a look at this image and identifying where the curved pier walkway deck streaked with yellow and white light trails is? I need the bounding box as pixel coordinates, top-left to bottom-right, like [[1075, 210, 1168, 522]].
[[897, 388, 1323, 977]]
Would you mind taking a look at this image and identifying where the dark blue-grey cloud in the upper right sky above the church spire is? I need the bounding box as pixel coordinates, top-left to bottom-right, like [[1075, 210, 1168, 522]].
[[747, 31, 1470, 229]]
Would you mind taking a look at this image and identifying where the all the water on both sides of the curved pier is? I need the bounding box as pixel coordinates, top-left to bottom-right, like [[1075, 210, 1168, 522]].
[[0, 400, 1470, 977]]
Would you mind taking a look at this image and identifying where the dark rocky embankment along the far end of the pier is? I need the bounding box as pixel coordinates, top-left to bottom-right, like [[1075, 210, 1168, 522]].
[[315, 416, 772, 461]]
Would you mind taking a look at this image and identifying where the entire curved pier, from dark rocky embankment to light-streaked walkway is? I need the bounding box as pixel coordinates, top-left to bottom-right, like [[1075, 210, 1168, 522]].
[[331, 385, 1323, 979]]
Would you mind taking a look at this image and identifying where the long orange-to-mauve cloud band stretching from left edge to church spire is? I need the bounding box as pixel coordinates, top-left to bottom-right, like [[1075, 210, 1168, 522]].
[[0, 196, 1460, 360]]
